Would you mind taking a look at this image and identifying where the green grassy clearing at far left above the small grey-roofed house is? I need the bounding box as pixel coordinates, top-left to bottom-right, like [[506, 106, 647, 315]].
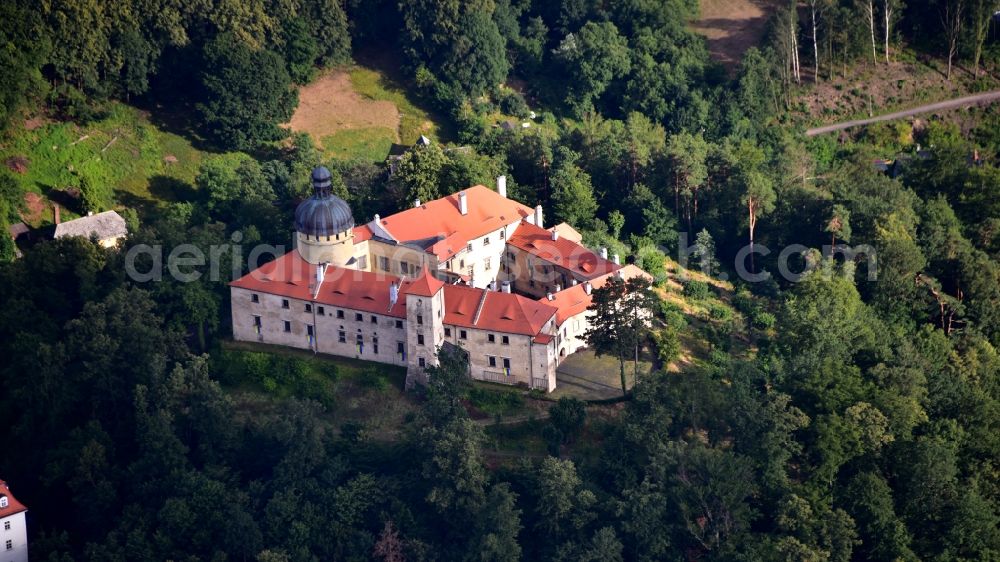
[[0, 103, 218, 226]]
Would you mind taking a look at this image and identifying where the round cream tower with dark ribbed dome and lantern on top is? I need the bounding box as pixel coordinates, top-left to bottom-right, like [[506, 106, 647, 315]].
[[295, 166, 354, 267]]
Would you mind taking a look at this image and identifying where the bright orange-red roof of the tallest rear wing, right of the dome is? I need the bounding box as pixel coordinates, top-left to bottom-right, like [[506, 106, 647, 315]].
[[374, 185, 534, 260]]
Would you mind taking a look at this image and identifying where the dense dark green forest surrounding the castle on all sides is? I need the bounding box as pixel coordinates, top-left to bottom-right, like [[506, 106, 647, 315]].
[[0, 0, 1000, 562]]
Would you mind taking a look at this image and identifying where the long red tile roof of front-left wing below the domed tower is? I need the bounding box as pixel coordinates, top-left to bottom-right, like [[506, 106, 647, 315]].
[[230, 250, 412, 318]]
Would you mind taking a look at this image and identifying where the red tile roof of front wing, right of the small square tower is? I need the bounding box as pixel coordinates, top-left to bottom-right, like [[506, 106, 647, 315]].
[[444, 285, 556, 336]]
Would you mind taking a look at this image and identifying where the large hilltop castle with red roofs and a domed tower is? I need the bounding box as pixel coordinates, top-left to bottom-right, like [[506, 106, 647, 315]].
[[230, 166, 647, 392]]
